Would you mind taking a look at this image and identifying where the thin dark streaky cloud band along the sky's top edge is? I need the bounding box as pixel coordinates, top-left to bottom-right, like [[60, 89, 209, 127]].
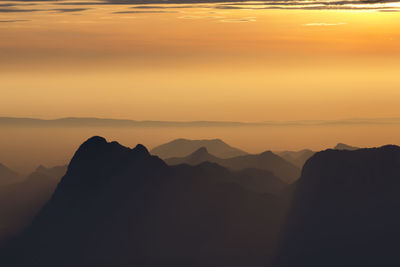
[[4, 0, 400, 13]]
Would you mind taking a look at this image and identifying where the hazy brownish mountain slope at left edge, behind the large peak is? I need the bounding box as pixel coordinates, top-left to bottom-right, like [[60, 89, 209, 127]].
[[0, 166, 66, 243]]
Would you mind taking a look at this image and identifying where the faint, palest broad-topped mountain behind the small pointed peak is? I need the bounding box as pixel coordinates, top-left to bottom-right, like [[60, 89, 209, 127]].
[[151, 139, 247, 159]]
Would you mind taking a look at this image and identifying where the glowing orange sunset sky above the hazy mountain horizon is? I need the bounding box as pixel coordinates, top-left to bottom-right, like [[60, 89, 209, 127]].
[[0, 0, 400, 172]]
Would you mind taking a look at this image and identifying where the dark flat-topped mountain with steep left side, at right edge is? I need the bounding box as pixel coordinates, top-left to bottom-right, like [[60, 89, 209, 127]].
[[277, 146, 400, 266]]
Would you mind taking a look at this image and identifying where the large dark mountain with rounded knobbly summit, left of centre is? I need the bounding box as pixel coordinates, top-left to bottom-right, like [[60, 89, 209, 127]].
[[0, 137, 283, 267]]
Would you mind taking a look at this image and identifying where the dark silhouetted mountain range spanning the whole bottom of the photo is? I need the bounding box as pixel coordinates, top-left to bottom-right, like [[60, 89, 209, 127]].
[[0, 137, 400, 267]]
